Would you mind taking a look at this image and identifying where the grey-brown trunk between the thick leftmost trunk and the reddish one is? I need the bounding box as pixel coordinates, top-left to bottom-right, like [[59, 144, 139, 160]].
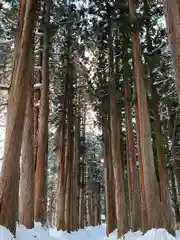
[[19, 47, 34, 228]]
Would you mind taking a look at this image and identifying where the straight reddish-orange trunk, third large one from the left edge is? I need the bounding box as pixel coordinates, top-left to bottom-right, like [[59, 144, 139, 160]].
[[35, 2, 49, 224]]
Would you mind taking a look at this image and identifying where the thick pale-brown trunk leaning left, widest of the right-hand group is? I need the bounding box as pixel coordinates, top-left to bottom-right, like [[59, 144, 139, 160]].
[[129, 0, 162, 228]]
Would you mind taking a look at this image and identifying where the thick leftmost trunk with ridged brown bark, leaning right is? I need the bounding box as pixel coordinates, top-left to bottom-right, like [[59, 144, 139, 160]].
[[0, 0, 37, 234]]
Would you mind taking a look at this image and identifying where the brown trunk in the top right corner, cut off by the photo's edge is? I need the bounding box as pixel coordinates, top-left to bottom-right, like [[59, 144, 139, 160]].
[[163, 0, 180, 103]]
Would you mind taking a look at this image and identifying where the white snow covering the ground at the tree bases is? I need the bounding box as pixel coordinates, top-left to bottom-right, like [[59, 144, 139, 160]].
[[0, 224, 180, 240]]
